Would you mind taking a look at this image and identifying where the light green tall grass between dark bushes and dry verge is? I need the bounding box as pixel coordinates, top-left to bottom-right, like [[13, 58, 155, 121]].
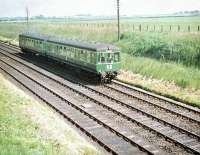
[[122, 53, 200, 89]]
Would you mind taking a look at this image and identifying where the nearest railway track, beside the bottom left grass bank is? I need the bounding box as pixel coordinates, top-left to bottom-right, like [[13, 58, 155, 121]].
[[0, 44, 159, 154]]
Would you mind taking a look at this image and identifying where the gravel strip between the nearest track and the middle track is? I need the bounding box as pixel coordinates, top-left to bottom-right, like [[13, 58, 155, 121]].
[[0, 53, 168, 153]]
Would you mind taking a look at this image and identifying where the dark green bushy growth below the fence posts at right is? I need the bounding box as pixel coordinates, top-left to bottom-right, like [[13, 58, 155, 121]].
[[118, 33, 200, 67]]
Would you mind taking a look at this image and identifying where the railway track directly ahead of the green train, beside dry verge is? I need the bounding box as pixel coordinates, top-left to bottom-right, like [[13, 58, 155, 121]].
[[106, 80, 200, 124]]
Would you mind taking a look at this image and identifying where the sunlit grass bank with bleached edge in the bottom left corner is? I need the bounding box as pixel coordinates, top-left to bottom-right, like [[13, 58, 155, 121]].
[[0, 74, 100, 155]]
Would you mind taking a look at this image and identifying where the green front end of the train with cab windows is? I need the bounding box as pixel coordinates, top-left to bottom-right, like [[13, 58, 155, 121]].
[[96, 48, 120, 82]]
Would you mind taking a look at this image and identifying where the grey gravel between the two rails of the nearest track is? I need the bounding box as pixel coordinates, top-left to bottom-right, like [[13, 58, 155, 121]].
[[0, 57, 146, 155]]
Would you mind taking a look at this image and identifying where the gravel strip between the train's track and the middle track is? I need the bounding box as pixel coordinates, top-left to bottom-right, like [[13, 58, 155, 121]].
[[94, 86, 200, 135]]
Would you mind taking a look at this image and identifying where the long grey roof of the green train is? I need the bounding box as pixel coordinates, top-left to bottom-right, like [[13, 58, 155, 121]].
[[20, 33, 119, 51]]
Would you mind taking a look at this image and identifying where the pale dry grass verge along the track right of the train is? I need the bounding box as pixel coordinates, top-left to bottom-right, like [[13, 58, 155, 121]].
[[118, 71, 200, 108]]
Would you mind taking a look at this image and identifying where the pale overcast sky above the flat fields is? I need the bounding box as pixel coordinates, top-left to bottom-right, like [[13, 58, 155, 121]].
[[0, 0, 200, 17]]
